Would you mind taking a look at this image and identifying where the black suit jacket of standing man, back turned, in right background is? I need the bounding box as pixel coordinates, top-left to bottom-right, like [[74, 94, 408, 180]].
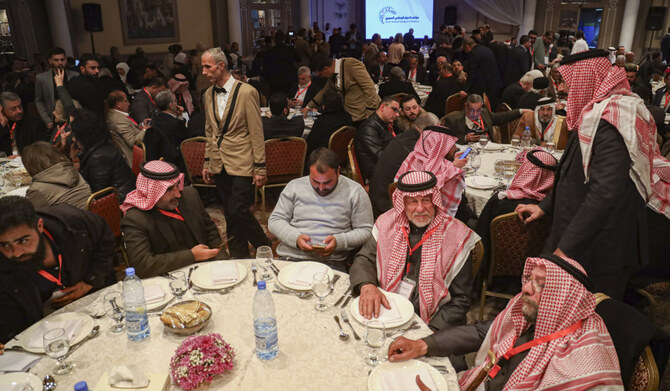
[[465, 45, 502, 100]]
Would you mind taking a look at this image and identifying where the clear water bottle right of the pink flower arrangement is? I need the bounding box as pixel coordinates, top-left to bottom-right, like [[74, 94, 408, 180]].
[[254, 281, 279, 360]]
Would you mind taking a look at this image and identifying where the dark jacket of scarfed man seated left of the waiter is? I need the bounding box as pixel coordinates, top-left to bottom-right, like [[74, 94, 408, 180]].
[[121, 186, 227, 278]]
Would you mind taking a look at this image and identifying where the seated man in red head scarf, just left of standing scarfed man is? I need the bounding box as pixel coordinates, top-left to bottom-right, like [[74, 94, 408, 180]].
[[475, 147, 558, 273]]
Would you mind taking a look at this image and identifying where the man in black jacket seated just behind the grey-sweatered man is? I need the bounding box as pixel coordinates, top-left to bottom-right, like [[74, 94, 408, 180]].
[[354, 96, 400, 180]]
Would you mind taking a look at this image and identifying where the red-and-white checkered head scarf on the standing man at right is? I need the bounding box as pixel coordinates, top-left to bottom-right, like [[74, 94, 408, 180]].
[[559, 51, 670, 218]]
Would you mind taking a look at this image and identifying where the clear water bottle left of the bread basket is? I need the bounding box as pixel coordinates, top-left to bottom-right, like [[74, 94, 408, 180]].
[[123, 267, 150, 341]]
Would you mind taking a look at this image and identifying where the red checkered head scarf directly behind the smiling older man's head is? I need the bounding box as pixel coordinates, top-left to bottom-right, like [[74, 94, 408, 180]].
[[395, 126, 465, 216]]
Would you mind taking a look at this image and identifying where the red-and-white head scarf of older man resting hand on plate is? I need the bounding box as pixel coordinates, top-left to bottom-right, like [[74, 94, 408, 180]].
[[373, 171, 479, 323]]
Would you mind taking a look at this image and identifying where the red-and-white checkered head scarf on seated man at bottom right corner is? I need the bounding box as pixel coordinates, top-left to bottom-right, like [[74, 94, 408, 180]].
[[460, 258, 622, 390]]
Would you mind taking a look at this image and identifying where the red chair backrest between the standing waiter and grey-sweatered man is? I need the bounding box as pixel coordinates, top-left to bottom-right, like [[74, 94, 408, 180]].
[[265, 137, 307, 184]]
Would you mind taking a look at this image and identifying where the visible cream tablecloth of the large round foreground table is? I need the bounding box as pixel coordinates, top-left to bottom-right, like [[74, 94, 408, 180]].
[[7, 260, 459, 390]]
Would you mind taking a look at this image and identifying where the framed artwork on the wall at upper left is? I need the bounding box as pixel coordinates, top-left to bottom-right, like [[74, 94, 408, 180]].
[[119, 0, 179, 45]]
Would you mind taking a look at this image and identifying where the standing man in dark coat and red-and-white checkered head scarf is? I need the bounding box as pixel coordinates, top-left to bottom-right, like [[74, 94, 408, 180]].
[[517, 50, 670, 298]]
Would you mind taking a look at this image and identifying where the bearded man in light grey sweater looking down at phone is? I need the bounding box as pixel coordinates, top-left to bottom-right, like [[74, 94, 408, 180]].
[[268, 148, 373, 271]]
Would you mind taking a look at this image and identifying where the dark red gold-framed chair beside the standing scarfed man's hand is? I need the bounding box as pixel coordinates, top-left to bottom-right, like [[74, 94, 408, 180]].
[[479, 212, 551, 320]]
